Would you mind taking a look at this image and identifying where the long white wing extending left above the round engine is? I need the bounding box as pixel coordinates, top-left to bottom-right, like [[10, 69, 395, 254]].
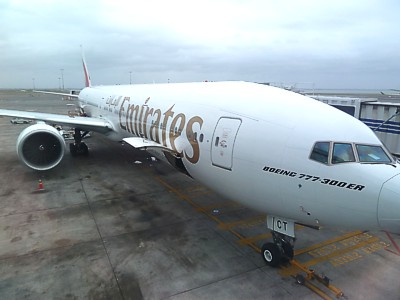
[[0, 109, 114, 133]]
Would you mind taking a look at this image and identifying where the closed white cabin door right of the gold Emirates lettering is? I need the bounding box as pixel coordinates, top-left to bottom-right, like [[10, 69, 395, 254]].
[[211, 118, 242, 170]]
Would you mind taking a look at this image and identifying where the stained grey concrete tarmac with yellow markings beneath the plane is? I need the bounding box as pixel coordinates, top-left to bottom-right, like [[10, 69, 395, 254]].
[[0, 91, 400, 300]]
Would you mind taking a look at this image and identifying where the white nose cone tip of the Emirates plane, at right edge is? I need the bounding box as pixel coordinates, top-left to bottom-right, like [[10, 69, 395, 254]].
[[378, 174, 400, 233]]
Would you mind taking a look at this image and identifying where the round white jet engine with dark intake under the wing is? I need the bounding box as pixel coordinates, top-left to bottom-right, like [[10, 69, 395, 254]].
[[17, 123, 65, 171]]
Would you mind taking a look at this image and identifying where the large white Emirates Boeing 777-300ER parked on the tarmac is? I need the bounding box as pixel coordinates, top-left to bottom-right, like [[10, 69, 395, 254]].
[[0, 56, 400, 267]]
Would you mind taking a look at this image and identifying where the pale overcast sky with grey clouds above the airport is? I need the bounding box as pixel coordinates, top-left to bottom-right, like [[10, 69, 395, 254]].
[[0, 0, 400, 89]]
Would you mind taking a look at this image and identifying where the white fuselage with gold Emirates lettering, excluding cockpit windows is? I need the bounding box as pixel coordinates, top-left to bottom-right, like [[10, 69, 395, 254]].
[[79, 82, 400, 232]]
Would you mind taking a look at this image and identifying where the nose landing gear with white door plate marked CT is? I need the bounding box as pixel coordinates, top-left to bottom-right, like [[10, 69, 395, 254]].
[[261, 216, 296, 267]]
